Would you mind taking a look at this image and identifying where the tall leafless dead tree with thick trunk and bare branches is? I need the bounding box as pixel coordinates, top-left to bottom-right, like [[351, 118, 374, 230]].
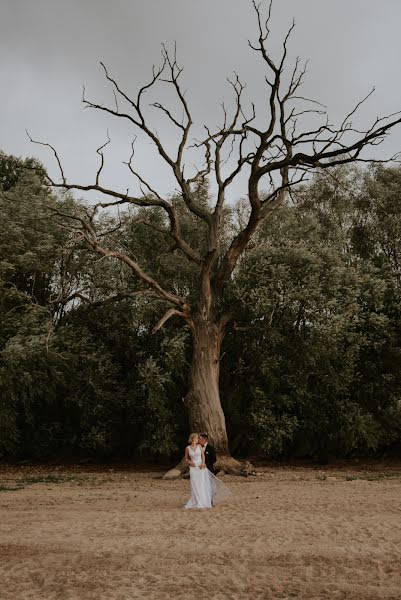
[[26, 2, 401, 474]]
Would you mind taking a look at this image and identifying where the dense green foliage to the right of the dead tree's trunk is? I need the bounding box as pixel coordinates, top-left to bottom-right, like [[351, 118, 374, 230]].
[[223, 166, 401, 459]]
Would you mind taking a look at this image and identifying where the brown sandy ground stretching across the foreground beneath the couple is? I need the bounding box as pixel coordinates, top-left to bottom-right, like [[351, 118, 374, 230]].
[[0, 464, 401, 600]]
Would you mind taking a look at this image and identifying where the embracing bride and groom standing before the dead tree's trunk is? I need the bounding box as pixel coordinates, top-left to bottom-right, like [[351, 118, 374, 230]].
[[185, 433, 231, 508]]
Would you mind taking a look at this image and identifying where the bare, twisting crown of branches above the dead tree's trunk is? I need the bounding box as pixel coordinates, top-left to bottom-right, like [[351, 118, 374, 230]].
[[29, 0, 401, 338]]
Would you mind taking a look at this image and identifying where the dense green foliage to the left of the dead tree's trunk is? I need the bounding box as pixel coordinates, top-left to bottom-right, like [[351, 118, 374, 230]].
[[0, 152, 185, 458]]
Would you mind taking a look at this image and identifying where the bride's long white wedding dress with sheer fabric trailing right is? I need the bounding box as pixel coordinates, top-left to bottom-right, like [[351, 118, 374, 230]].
[[185, 444, 231, 508]]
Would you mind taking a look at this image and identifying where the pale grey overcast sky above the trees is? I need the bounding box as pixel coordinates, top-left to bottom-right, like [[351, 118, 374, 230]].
[[0, 0, 401, 203]]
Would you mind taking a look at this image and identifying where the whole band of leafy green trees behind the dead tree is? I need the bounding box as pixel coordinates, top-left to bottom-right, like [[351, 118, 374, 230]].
[[0, 153, 401, 460]]
